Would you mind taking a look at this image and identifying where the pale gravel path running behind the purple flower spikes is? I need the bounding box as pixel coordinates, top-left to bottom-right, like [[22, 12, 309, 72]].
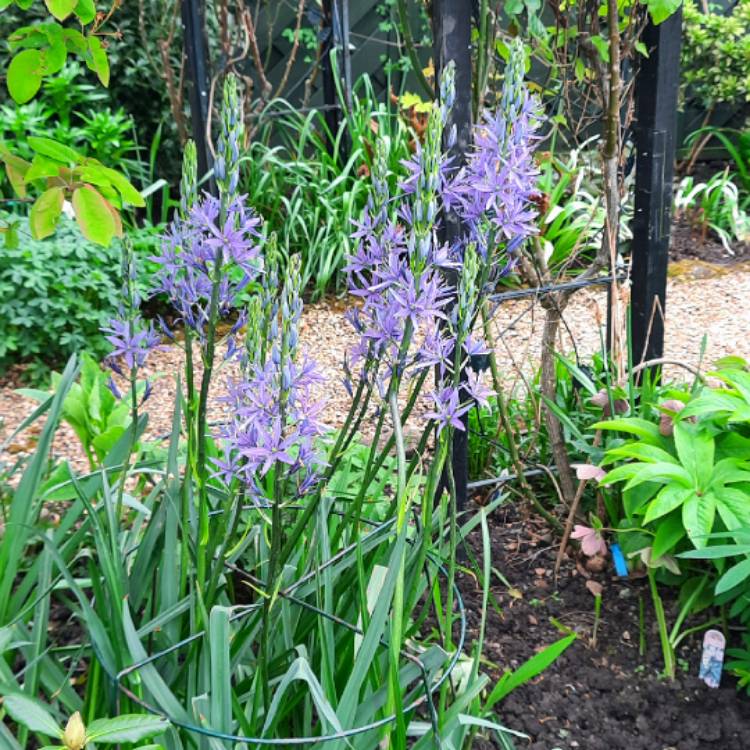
[[0, 261, 750, 468]]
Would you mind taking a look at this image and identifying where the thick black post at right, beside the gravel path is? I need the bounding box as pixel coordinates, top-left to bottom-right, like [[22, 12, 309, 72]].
[[631, 10, 682, 370]]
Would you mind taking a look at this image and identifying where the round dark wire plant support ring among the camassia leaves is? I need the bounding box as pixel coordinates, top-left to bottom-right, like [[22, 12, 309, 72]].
[[110, 506, 466, 746]]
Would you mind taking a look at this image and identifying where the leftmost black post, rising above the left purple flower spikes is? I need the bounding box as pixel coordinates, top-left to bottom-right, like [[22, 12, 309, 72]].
[[182, 0, 211, 185]]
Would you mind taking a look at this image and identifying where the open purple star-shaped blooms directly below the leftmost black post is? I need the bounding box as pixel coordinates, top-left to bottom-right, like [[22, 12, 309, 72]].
[[151, 194, 261, 340]]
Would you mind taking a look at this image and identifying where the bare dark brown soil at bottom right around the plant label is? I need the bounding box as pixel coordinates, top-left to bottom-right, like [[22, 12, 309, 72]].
[[462, 504, 750, 750]]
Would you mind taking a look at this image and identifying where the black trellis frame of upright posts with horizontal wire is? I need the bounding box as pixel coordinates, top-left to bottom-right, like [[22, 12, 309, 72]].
[[182, 0, 682, 507]]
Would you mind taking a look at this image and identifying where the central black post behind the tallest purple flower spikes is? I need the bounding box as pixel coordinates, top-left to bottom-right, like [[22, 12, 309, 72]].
[[432, 0, 472, 510]]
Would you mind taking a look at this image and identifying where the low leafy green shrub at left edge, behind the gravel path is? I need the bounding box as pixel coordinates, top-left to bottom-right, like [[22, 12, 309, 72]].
[[0, 220, 120, 369]]
